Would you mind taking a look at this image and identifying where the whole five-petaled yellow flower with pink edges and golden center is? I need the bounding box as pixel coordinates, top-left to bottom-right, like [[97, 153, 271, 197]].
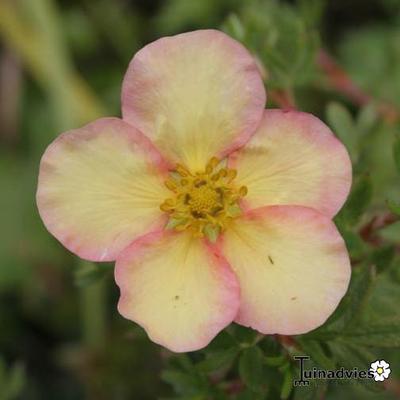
[[37, 30, 351, 352]]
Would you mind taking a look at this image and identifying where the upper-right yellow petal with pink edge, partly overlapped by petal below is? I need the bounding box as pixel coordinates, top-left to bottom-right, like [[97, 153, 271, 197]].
[[231, 110, 351, 216]]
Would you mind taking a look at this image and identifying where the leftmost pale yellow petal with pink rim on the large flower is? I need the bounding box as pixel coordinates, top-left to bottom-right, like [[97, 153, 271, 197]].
[[37, 118, 169, 261]]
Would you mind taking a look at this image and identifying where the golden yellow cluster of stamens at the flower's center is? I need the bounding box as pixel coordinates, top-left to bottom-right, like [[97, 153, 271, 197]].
[[160, 157, 247, 241]]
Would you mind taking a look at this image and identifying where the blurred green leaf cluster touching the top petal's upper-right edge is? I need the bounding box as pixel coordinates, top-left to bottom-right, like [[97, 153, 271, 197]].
[[223, 1, 319, 90]]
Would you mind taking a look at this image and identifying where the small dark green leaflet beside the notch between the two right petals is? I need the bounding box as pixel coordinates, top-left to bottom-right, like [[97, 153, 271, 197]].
[[337, 175, 372, 227]]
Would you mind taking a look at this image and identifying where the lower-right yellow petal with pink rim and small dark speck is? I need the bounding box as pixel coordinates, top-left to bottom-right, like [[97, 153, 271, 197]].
[[221, 206, 350, 335]]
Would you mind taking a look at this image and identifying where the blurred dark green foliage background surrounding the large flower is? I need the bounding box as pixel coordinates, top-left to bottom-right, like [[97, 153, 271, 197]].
[[0, 0, 400, 400]]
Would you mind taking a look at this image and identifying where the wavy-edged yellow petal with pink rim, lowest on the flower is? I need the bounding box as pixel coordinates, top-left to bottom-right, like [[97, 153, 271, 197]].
[[115, 231, 239, 352]]
